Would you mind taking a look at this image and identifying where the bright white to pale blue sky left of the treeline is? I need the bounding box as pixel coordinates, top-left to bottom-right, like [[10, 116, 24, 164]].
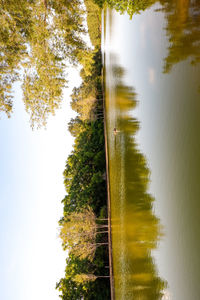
[[0, 65, 80, 300]]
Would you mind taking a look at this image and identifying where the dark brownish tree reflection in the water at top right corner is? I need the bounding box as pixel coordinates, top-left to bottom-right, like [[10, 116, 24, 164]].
[[160, 0, 200, 73]]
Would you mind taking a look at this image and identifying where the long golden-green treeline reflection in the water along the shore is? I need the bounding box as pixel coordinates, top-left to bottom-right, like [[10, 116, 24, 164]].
[[108, 57, 167, 300]]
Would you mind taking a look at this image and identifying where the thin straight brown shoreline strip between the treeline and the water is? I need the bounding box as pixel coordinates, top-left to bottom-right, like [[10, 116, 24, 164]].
[[102, 68, 115, 300]]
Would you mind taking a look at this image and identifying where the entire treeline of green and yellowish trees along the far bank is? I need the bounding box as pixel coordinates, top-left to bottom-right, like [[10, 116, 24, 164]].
[[56, 0, 110, 300]]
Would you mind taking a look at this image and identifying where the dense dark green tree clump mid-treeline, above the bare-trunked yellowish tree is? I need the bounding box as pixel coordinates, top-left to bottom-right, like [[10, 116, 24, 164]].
[[63, 121, 106, 216]]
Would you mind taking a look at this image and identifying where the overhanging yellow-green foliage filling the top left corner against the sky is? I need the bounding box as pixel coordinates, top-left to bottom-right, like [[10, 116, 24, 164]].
[[0, 0, 86, 127]]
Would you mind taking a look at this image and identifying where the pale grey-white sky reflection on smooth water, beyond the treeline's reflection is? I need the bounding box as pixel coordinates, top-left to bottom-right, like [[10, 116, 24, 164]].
[[104, 1, 200, 300]]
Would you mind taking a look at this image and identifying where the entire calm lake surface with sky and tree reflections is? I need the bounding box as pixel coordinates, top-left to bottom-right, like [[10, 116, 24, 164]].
[[103, 0, 200, 300]]
